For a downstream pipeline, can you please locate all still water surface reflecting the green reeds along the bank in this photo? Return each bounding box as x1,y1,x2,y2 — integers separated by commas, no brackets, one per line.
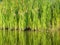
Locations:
0,30,60,45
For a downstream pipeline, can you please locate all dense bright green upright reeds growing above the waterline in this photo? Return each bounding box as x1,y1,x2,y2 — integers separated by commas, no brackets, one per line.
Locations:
0,0,60,30
